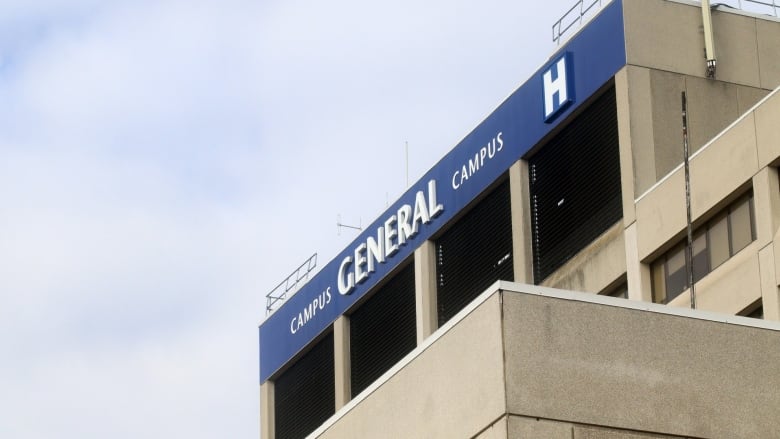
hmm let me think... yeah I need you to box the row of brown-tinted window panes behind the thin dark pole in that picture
[652,193,756,303]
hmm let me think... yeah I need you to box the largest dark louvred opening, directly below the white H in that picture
[528,87,623,284]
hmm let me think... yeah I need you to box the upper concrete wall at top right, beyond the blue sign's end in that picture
[616,0,780,197]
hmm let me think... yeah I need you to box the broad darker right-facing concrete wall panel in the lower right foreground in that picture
[503,293,780,439]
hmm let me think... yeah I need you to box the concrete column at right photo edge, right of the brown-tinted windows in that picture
[753,167,780,320]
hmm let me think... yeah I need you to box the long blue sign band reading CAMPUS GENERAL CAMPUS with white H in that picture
[260,0,626,383]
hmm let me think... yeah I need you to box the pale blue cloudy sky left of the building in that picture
[0,0,588,439]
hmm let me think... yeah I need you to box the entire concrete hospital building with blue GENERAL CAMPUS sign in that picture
[260,0,780,439]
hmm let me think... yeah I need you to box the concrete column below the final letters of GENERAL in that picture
[414,241,439,345]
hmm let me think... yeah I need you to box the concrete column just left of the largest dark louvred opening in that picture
[509,160,534,284]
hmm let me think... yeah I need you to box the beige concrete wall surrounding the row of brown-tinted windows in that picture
[626,88,780,319]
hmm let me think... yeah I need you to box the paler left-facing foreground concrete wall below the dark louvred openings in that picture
[319,294,505,439]
